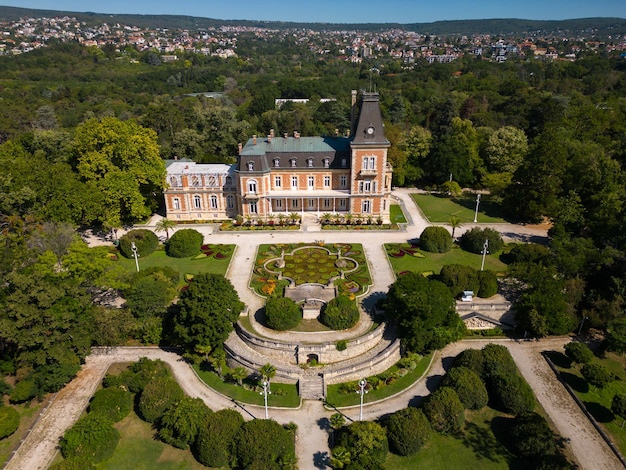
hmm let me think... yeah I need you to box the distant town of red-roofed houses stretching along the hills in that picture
[0,10,626,62]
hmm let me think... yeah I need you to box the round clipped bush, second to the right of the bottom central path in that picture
[386,407,430,456]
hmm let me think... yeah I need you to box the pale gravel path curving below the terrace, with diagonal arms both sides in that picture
[6,338,623,470]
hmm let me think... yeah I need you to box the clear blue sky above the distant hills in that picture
[0,0,626,23]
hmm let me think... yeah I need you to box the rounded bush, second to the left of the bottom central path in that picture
[193,409,244,468]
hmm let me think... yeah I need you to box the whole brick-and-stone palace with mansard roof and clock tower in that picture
[165,91,392,221]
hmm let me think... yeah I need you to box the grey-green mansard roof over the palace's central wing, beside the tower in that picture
[238,136,350,173]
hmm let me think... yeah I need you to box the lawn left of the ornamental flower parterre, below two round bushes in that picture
[113,245,235,284]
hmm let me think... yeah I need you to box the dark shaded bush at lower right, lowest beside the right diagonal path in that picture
[510,413,557,458]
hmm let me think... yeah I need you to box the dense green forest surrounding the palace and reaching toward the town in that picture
[0,33,626,395]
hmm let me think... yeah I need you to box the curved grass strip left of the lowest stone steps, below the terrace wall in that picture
[193,365,300,408]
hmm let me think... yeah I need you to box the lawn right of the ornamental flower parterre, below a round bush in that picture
[385,243,507,274]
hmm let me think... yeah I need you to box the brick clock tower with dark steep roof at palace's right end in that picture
[350,92,392,220]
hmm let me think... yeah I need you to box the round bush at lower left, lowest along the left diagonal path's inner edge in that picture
[59,413,120,462]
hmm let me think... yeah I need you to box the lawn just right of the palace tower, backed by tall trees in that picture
[411,194,507,224]
